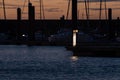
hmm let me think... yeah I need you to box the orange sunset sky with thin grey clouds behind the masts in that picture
[0,0,120,19]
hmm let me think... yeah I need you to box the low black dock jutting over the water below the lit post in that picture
[66,42,120,57]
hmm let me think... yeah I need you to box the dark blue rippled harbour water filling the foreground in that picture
[0,45,120,80]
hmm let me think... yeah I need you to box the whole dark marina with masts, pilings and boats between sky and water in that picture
[0,0,120,56]
